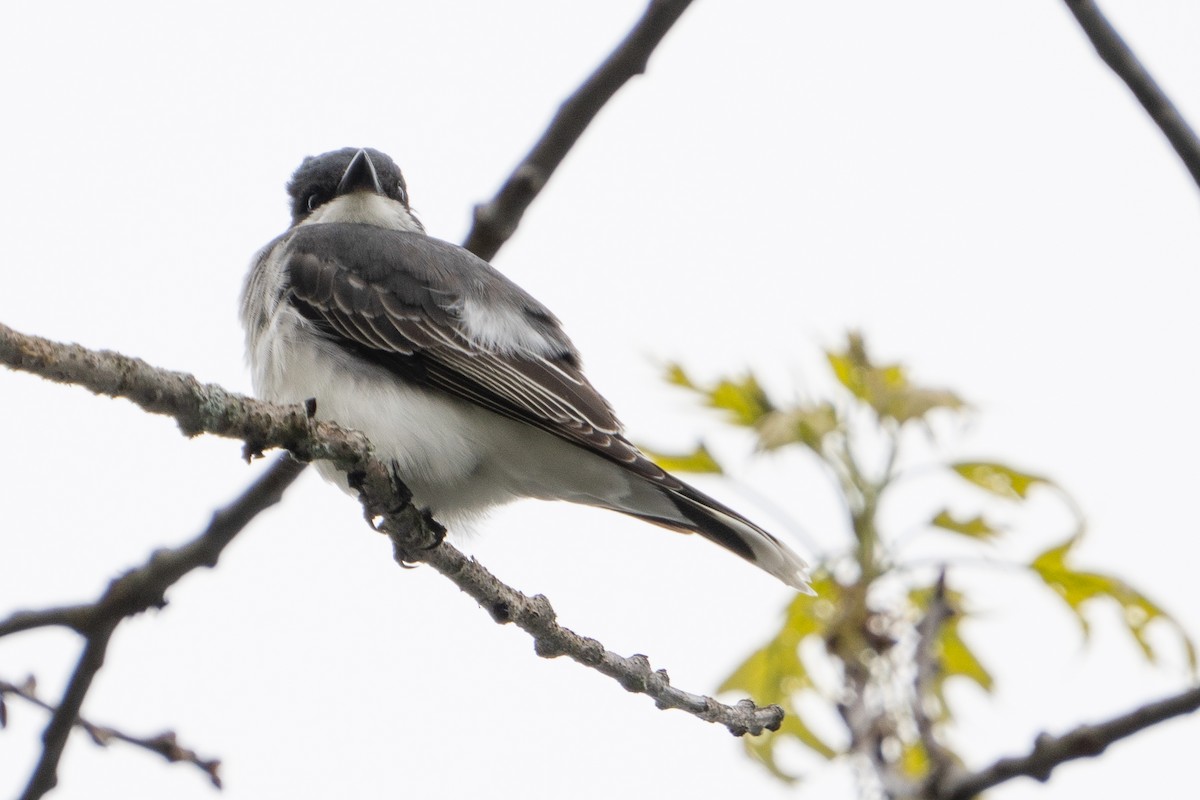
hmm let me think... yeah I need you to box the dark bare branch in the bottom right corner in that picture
[936,687,1200,800]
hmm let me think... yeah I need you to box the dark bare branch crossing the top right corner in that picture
[1064,0,1200,186]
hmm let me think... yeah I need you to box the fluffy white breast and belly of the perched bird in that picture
[250,293,668,524]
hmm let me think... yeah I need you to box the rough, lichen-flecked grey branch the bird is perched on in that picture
[0,324,784,735]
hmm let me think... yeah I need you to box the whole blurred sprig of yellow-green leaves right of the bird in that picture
[656,333,1196,795]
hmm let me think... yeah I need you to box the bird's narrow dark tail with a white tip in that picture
[617,479,815,595]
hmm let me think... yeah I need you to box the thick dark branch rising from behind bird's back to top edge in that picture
[463,0,691,260]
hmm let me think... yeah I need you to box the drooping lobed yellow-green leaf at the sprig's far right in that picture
[1028,535,1196,674]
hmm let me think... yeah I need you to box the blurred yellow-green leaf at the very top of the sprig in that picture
[826,333,966,425]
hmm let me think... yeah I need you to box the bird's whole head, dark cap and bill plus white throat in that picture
[288,148,425,233]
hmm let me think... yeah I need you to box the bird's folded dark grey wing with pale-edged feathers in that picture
[277,223,679,488]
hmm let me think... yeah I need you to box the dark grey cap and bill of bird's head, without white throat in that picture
[288,148,420,225]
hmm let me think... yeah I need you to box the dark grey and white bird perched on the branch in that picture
[241,148,812,594]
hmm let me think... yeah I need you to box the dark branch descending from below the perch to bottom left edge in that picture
[11,455,304,800]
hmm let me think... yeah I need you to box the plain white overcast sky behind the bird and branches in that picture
[0,0,1200,800]
